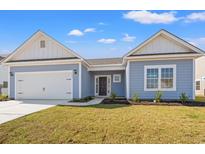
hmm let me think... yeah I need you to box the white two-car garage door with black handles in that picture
[15,71,73,99]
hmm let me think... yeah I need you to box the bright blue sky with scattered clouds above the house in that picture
[0,10,205,58]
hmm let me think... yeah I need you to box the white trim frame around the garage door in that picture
[14,70,74,99]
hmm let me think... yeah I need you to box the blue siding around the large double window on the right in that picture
[129,60,193,99]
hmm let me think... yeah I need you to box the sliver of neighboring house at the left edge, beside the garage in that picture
[0,55,8,95]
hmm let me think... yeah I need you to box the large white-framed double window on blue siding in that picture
[144,65,176,91]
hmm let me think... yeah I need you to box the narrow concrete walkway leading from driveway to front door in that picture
[59,98,104,106]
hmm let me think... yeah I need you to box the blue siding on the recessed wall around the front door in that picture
[91,71,125,96]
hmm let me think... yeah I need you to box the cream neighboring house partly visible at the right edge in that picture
[195,56,205,96]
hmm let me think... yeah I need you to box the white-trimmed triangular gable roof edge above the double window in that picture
[123,29,205,57]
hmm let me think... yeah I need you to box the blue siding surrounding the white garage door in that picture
[10,64,79,98]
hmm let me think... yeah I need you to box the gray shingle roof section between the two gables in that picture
[86,58,122,65]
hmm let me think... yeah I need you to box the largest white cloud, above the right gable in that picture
[123,11,179,24]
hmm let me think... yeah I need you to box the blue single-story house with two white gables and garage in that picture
[3,30,204,99]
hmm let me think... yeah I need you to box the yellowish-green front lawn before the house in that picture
[0,105,205,143]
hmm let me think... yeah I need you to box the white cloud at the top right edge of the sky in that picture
[185,12,205,22]
